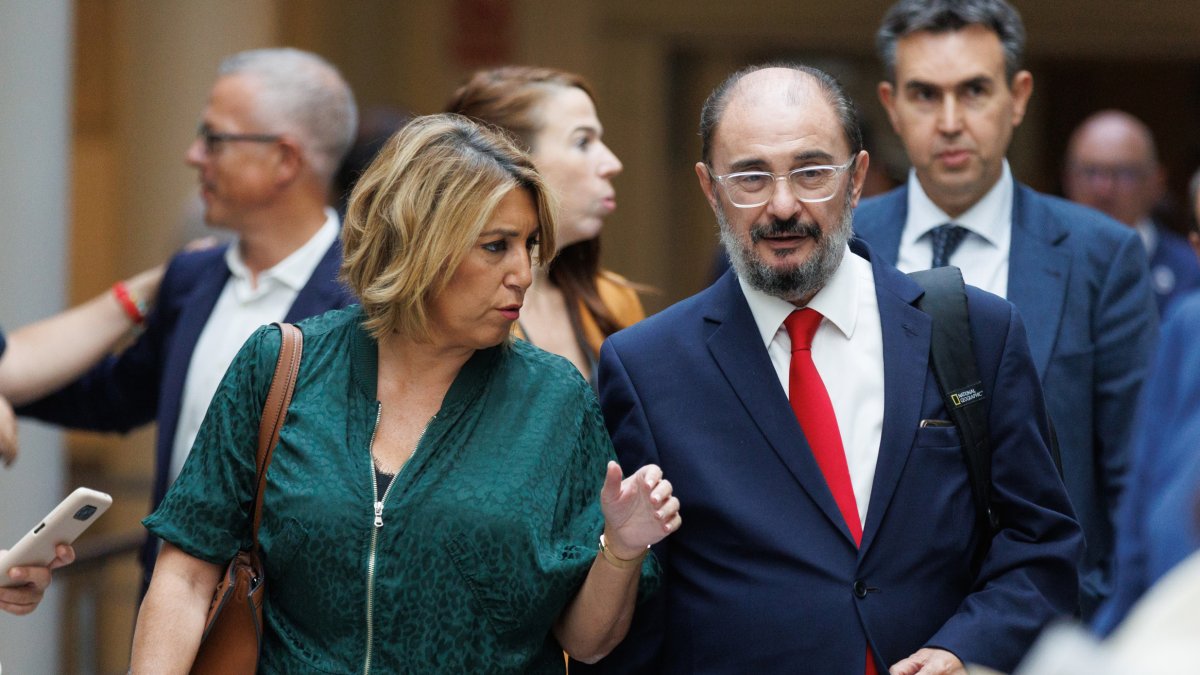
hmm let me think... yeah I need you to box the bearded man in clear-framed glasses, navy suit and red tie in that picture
[572,65,1082,675]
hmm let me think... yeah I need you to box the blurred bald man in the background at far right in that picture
[1062,110,1200,313]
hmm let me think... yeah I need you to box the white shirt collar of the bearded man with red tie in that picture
[738,241,870,347]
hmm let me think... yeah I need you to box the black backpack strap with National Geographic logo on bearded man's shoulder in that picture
[908,267,1000,538]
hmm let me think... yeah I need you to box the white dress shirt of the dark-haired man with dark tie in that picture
[896,160,1014,298]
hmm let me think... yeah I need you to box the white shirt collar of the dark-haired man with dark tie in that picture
[900,160,1013,249]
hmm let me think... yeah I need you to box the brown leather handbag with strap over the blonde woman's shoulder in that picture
[192,323,304,675]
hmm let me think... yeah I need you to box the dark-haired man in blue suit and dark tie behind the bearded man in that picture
[854,0,1158,619]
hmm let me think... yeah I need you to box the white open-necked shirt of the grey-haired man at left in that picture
[170,209,340,482]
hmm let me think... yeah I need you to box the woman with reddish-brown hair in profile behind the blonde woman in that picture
[446,66,646,382]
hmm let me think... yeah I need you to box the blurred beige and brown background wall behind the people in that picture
[51,0,1200,671]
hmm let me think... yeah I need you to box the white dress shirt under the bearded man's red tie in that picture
[738,242,883,525]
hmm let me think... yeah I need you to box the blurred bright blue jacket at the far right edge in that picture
[1096,293,1200,634]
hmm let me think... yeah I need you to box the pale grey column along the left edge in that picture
[0,0,71,673]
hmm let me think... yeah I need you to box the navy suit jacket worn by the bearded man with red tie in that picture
[585,240,1082,675]
